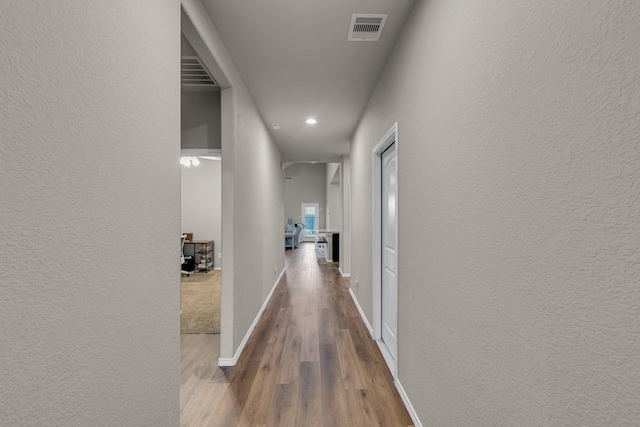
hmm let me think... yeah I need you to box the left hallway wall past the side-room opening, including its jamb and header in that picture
[182,0,285,360]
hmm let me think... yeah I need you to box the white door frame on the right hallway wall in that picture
[371,122,400,381]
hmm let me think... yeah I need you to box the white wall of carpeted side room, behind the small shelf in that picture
[180,159,222,268]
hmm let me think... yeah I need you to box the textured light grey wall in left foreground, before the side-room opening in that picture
[0,0,180,426]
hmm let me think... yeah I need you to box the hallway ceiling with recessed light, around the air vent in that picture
[196,0,414,162]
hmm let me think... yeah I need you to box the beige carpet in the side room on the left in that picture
[180,270,220,334]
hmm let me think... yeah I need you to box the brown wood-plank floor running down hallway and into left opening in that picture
[180,243,413,427]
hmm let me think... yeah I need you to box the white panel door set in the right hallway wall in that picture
[381,144,398,361]
